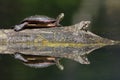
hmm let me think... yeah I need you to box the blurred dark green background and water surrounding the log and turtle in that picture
[0,0,120,80]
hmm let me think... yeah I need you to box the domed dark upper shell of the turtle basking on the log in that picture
[21,15,56,24]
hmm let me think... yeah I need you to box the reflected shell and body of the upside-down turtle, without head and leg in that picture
[24,55,55,68]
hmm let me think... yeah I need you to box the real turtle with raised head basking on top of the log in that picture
[14,13,64,31]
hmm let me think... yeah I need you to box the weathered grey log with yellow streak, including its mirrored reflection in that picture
[0,21,120,64]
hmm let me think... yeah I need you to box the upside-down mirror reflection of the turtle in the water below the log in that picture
[14,53,64,70]
